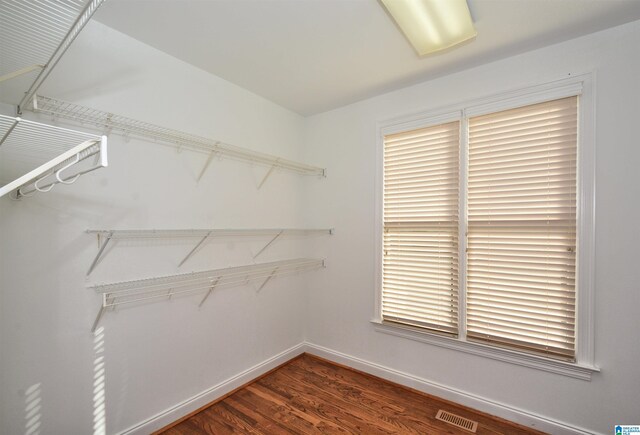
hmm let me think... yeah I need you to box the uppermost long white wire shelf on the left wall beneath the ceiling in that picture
[33,95,325,177]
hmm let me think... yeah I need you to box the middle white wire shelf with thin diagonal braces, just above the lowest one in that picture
[87,228,333,276]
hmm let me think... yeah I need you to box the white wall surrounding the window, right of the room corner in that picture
[303,18,640,433]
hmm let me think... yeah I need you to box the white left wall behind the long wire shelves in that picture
[0,22,322,435]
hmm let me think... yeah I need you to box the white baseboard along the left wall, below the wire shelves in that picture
[120,343,305,435]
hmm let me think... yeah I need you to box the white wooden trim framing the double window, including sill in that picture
[372,73,600,380]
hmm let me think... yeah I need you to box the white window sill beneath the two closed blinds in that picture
[371,320,600,381]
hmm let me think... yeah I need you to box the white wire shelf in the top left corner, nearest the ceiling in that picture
[0,0,103,114]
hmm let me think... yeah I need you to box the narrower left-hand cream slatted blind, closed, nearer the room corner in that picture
[382,121,460,335]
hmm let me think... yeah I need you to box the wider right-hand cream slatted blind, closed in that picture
[466,97,578,360]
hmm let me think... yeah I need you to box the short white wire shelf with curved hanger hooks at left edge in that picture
[0,115,108,199]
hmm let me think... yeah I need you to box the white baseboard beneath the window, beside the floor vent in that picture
[304,342,596,435]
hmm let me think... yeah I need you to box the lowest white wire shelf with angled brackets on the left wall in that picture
[89,258,324,331]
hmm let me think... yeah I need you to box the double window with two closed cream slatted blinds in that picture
[378,78,593,374]
